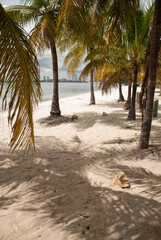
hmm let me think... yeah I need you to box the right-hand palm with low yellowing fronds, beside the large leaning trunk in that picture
[82,6,153,120]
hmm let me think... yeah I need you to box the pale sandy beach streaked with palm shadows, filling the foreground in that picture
[0,87,161,240]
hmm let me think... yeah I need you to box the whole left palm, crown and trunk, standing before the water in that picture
[8,0,62,116]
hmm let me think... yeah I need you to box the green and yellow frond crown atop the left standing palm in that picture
[6,0,61,52]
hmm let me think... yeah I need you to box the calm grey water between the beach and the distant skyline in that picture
[0,82,98,110]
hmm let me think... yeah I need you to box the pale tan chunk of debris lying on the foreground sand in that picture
[113,171,130,188]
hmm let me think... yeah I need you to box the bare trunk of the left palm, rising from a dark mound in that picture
[50,42,61,116]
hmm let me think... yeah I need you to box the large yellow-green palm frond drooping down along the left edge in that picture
[0,4,41,151]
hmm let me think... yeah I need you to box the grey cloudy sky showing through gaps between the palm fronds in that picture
[0,0,153,79]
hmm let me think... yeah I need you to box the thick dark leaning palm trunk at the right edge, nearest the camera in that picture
[139,0,161,149]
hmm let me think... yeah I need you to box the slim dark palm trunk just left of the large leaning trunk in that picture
[127,64,138,120]
